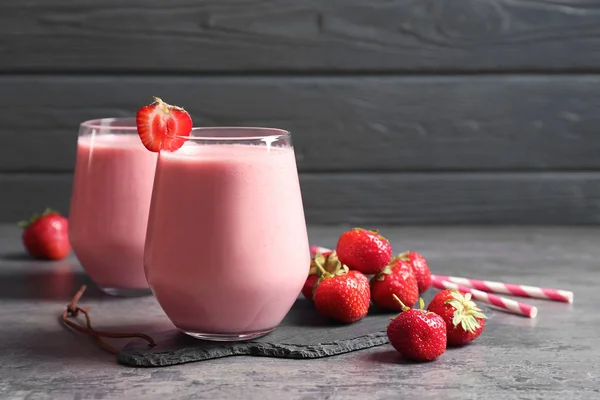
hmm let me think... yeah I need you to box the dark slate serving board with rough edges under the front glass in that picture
[117,299,397,367]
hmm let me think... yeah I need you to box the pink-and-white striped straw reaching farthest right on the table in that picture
[432,275,573,303]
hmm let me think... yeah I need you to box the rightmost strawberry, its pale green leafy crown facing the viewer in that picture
[427,290,486,346]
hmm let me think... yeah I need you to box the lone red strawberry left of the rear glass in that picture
[19,209,71,260]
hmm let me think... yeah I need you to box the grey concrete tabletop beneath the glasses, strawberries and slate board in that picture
[0,226,600,399]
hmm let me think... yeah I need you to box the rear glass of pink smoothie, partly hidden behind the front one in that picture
[69,118,158,296]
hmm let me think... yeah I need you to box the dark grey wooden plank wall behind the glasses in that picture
[0,0,600,225]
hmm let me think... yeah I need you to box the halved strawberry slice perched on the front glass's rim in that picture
[136,97,192,152]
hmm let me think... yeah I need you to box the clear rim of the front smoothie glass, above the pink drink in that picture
[173,126,291,142]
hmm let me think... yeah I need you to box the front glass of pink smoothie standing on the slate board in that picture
[145,127,310,341]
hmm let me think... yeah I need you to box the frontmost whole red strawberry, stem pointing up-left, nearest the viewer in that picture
[387,299,446,361]
